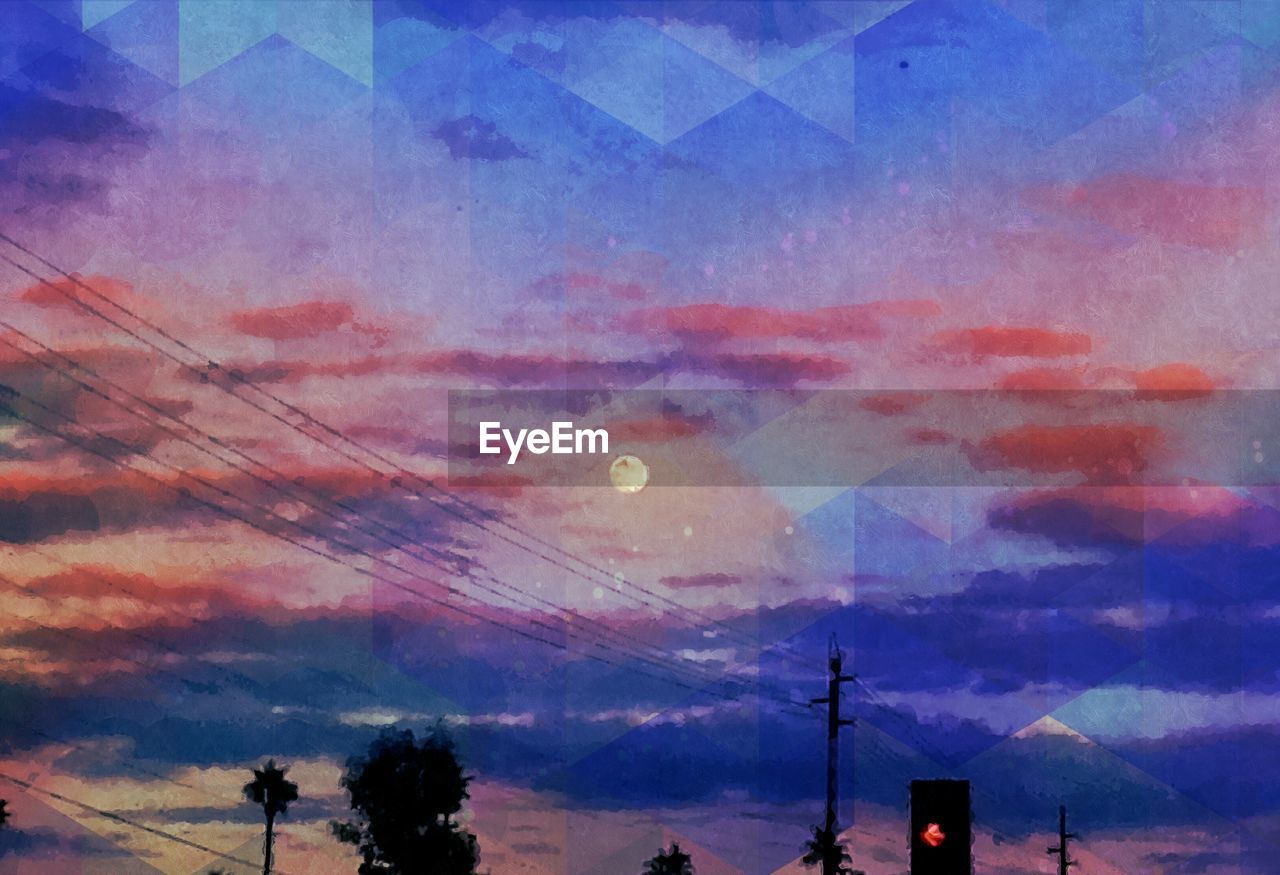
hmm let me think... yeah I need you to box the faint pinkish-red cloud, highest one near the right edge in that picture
[1030,174,1265,249]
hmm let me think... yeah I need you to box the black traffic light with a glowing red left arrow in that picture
[911,780,973,875]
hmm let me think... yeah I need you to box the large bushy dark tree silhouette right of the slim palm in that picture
[330,727,480,875]
